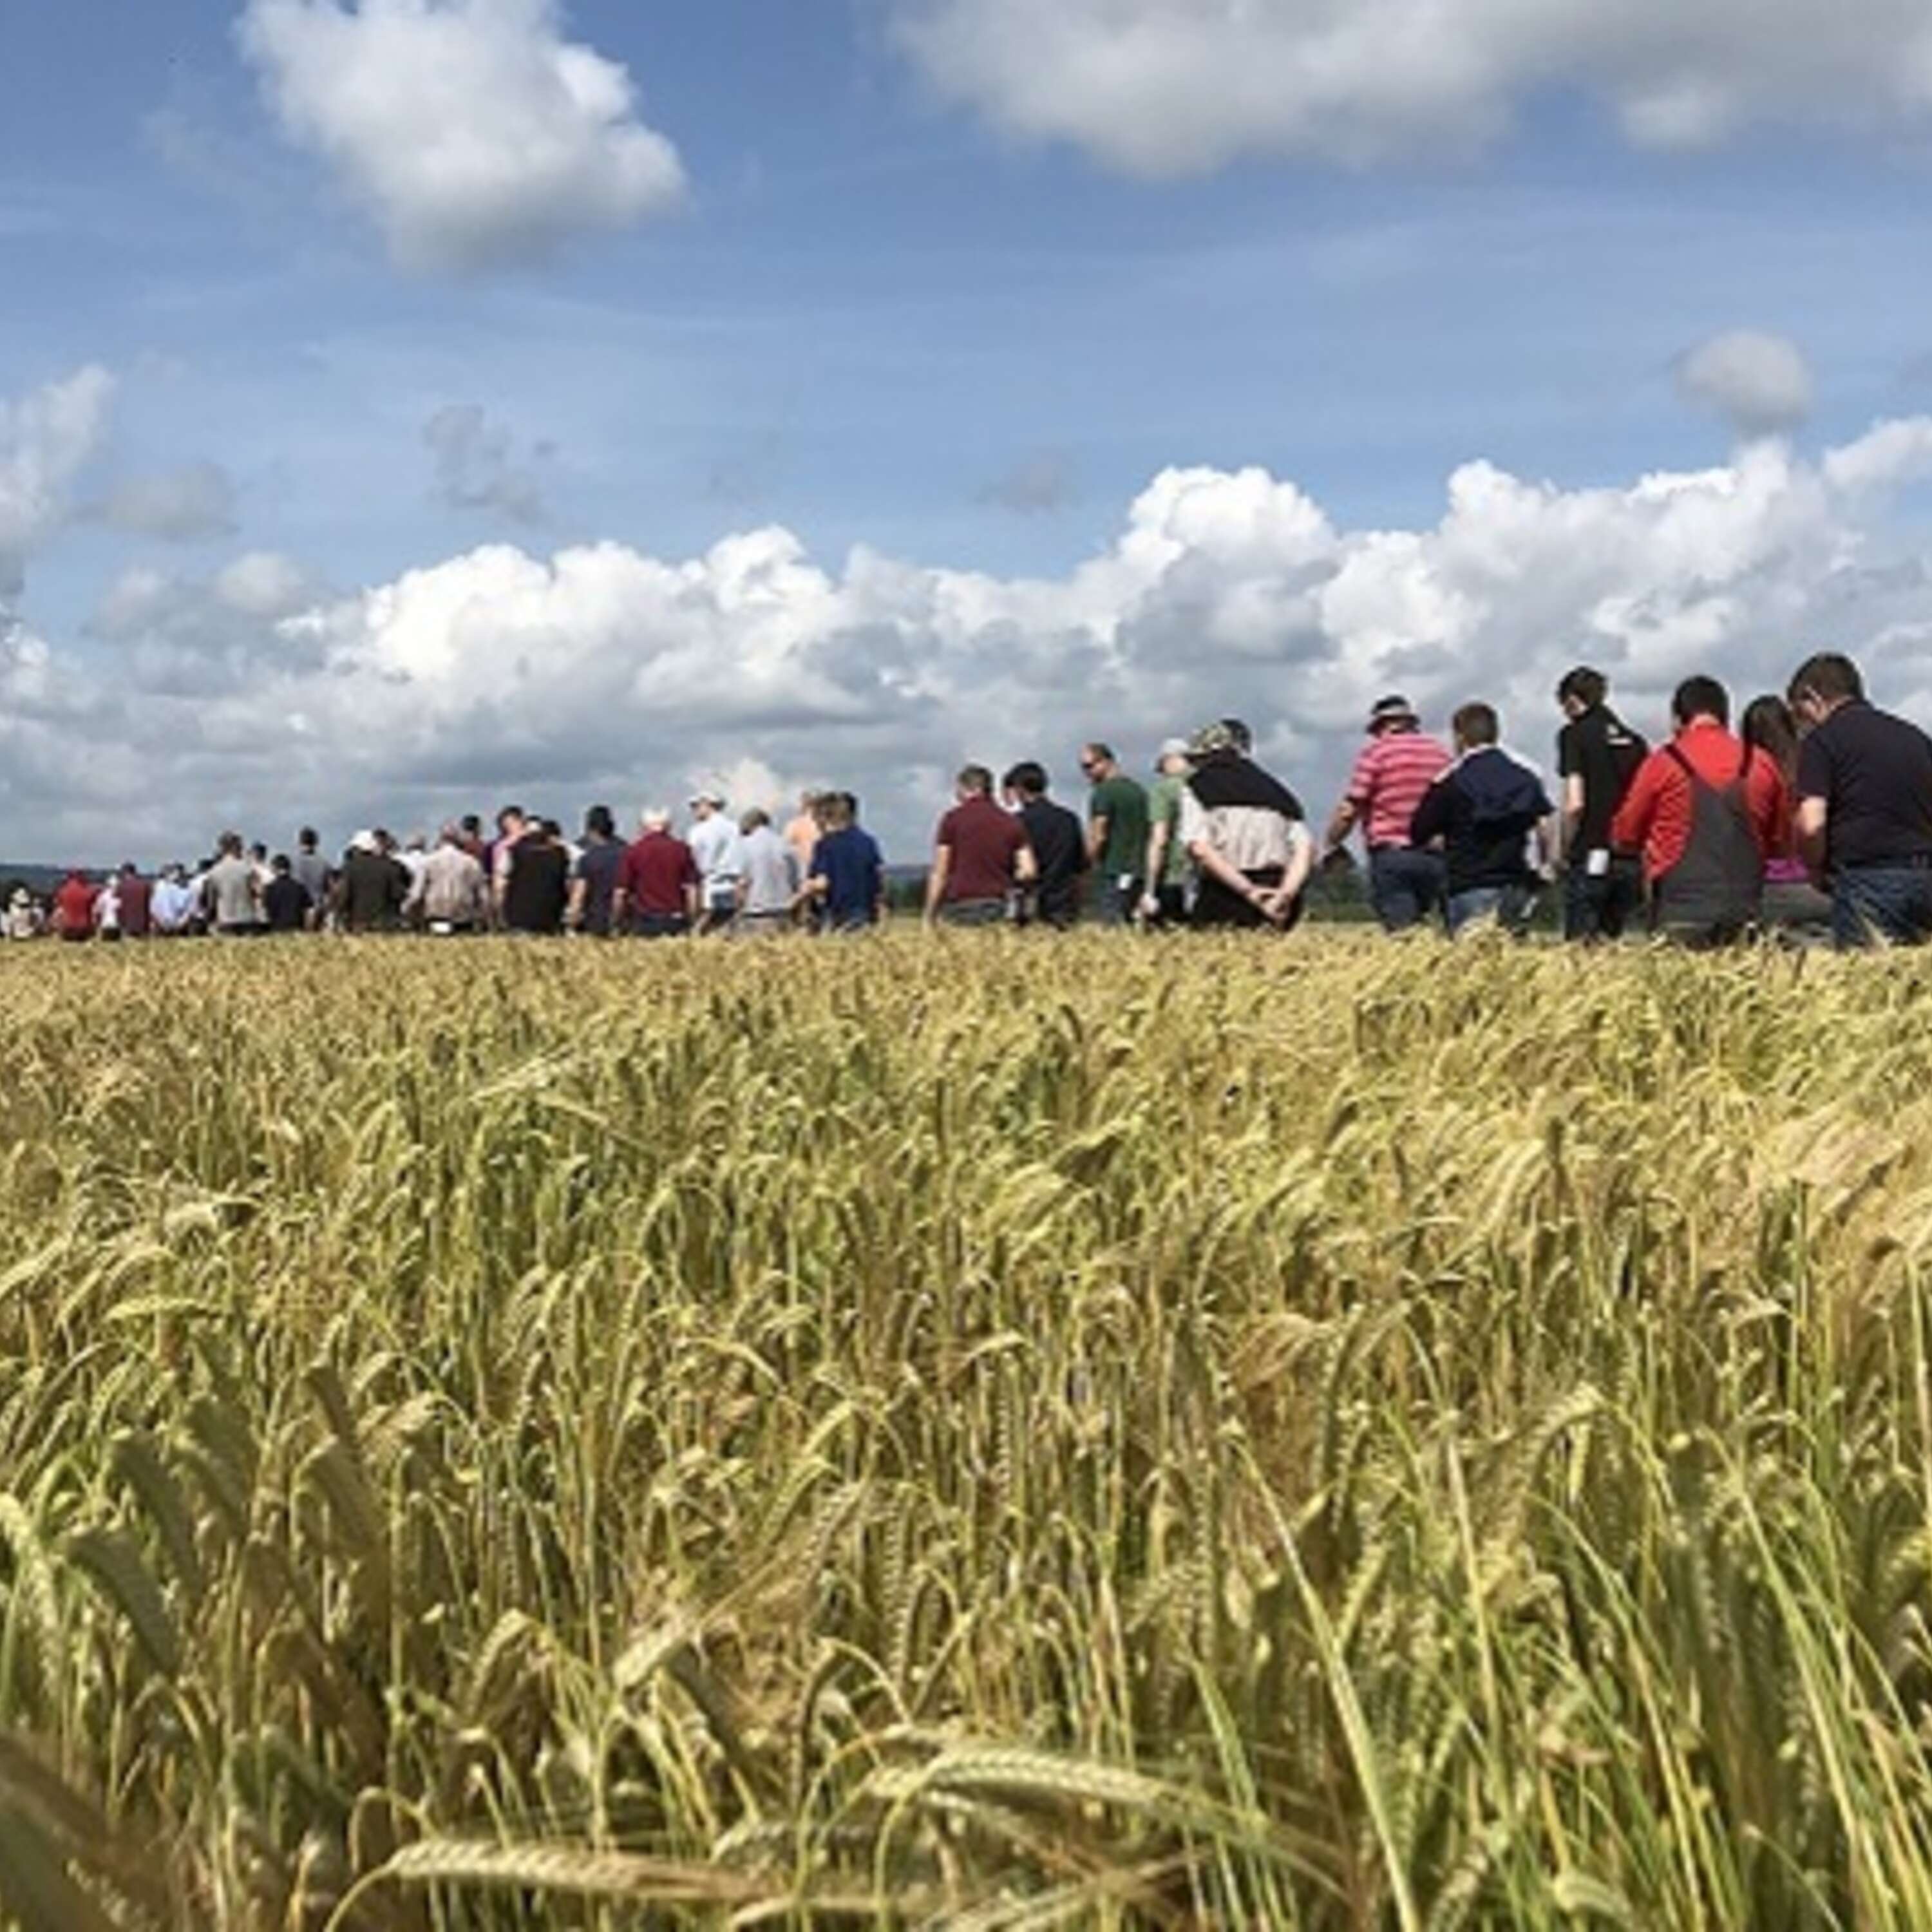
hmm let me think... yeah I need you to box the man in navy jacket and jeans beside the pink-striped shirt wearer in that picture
[1408,703,1555,937]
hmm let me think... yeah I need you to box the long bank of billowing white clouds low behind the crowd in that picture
[11,377,1932,858]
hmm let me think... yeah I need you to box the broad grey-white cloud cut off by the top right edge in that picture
[887,0,1932,176]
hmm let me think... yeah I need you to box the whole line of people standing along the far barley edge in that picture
[11,653,1932,947]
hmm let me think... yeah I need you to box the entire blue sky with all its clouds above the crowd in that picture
[0,0,1932,864]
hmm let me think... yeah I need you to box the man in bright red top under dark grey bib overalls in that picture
[1609,678,1789,945]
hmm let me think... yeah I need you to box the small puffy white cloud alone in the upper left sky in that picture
[238,0,684,272]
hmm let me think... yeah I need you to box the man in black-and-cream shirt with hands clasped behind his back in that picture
[1180,719,1316,931]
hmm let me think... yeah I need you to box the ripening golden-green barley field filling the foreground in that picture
[0,933,1932,1932]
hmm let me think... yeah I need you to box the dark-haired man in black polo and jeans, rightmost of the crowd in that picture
[1789,651,1932,947]
